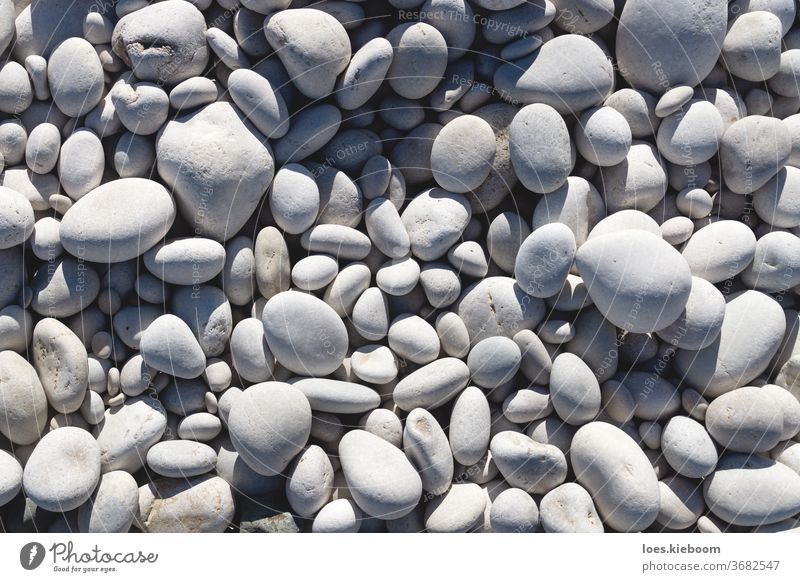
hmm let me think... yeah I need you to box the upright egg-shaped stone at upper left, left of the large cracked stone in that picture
[47,38,105,117]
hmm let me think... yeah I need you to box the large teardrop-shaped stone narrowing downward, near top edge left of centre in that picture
[264,8,350,99]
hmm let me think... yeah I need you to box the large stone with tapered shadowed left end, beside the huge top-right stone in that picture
[494,34,612,114]
